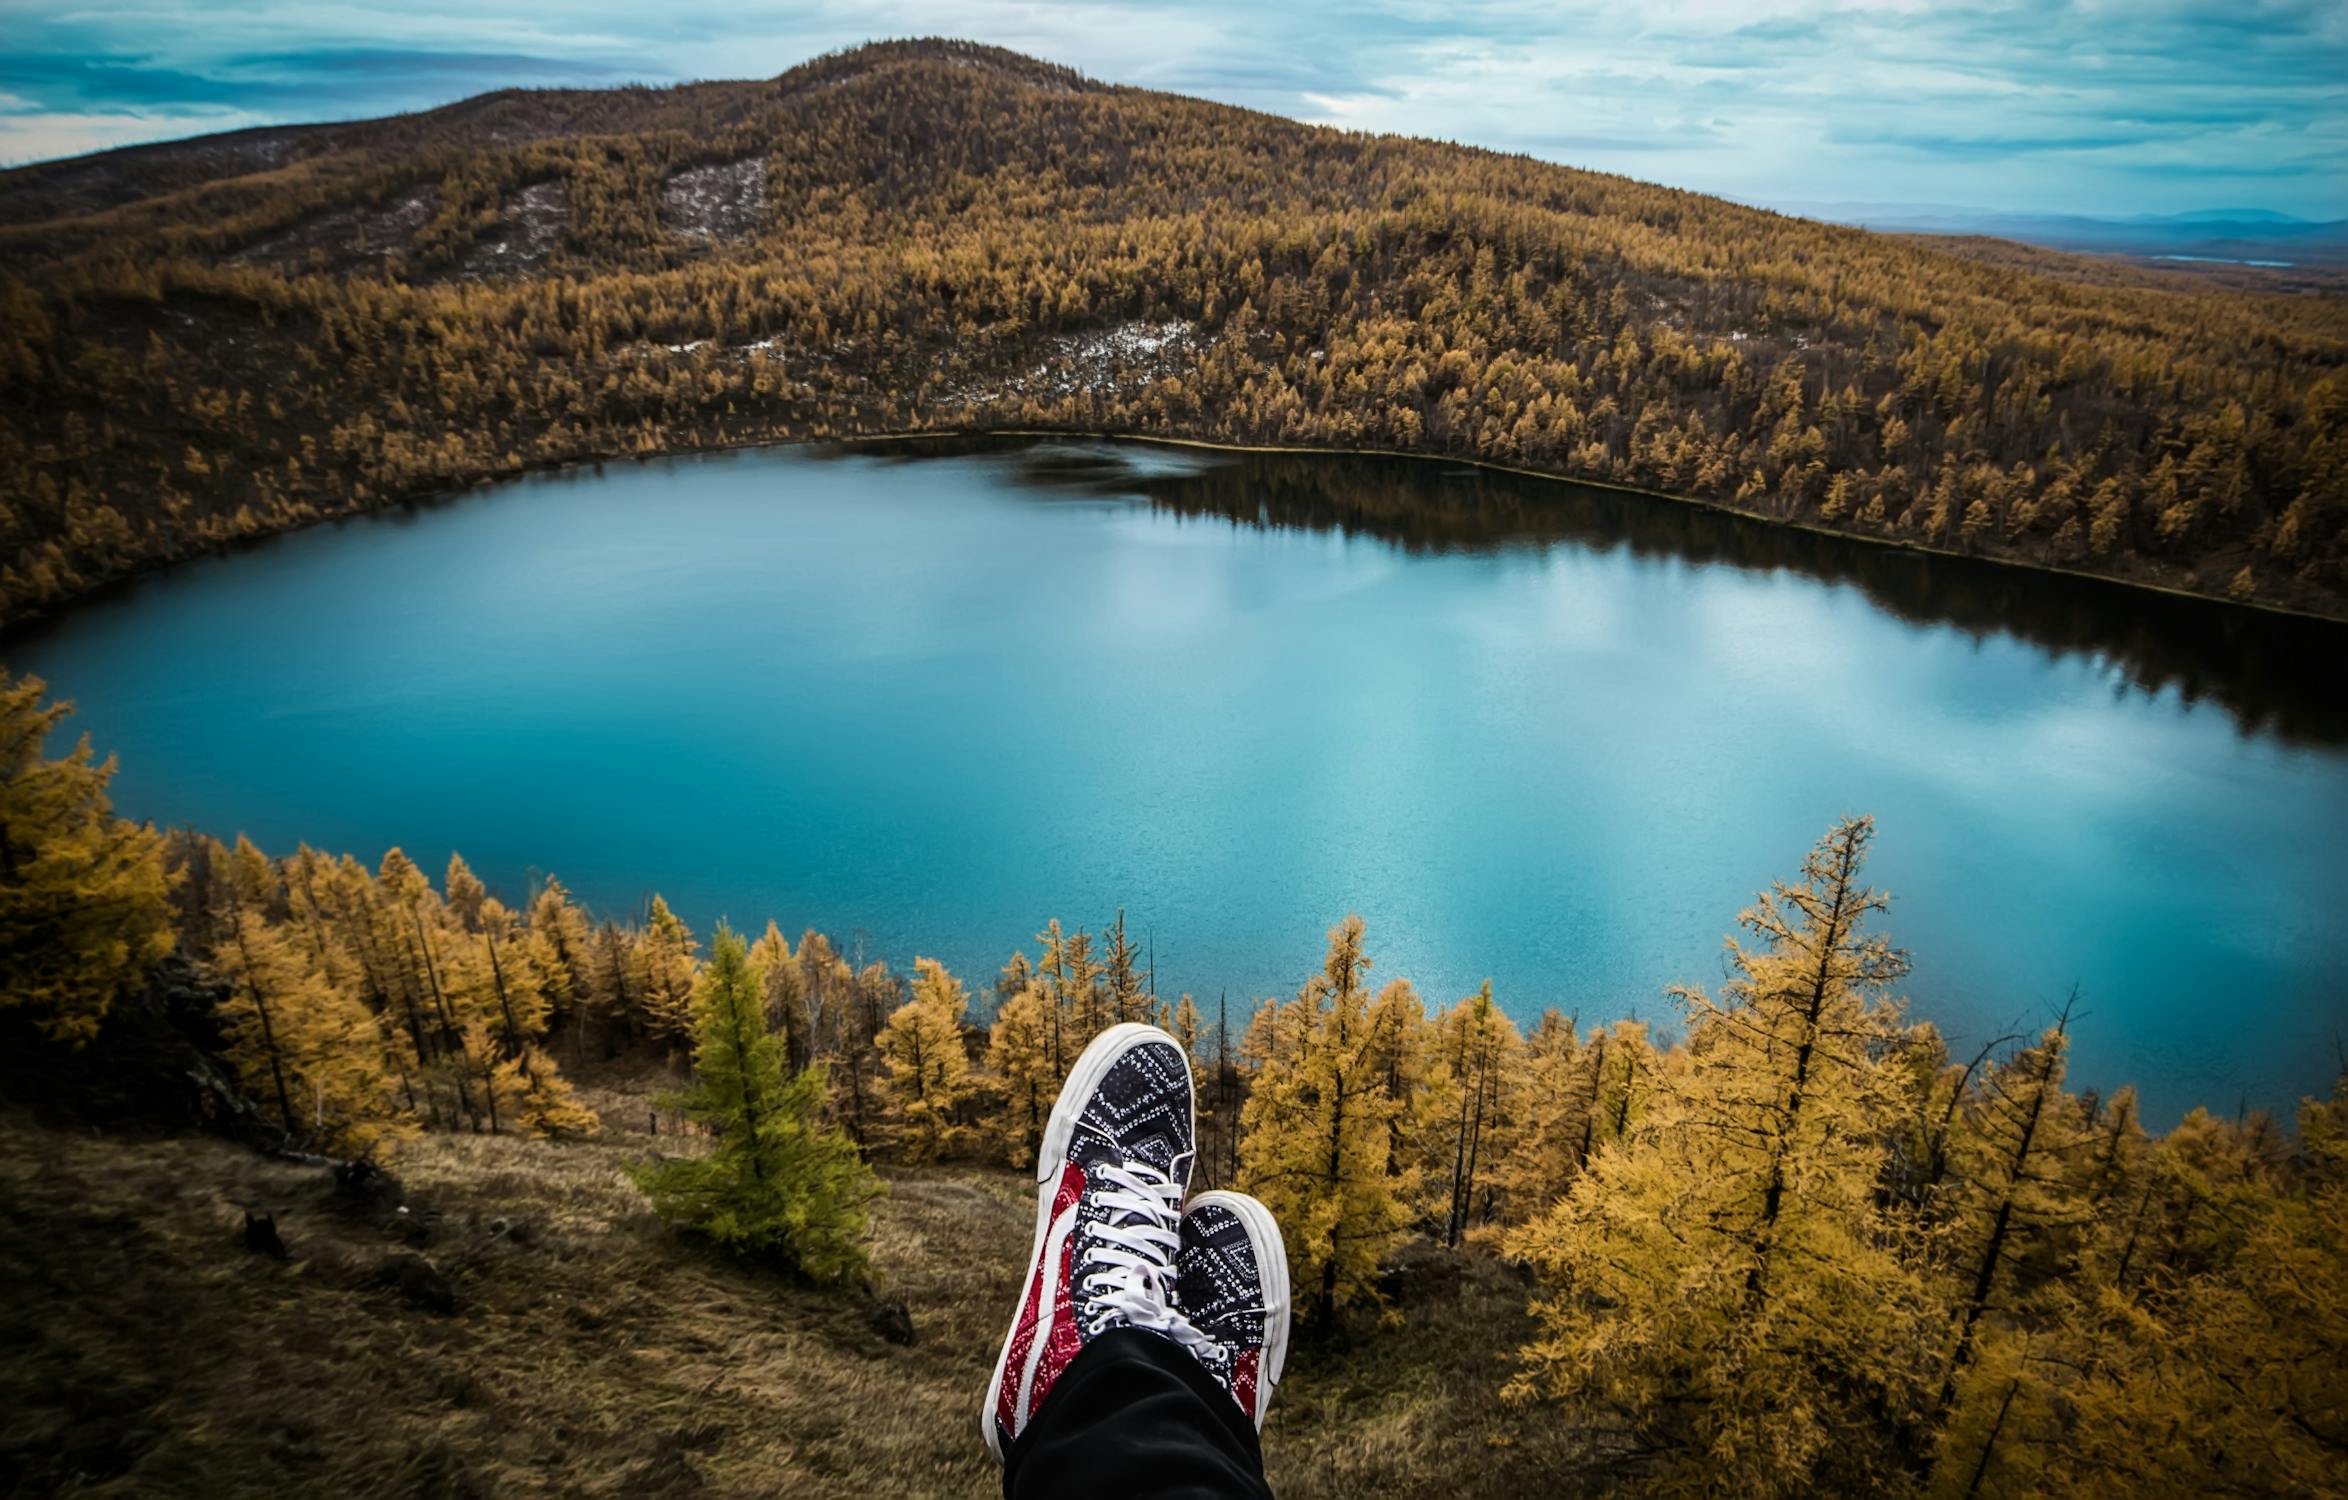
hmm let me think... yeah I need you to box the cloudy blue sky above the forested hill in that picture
[0,0,2348,218]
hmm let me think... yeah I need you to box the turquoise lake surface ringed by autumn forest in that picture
[7,444,2348,1122]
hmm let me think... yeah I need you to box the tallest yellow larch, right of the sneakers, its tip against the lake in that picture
[1510,819,1937,1495]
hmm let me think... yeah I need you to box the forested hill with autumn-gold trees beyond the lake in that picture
[0,42,2348,617]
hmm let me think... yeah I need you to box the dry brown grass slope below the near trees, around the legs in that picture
[0,1085,1606,1498]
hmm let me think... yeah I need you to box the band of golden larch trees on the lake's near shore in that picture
[0,678,2348,1495]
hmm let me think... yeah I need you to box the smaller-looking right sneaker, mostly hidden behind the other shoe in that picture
[1174,1192,1289,1432]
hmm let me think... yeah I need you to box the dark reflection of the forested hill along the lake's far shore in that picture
[848,439,2348,746]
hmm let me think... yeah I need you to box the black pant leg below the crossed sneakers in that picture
[1003,1329,1273,1500]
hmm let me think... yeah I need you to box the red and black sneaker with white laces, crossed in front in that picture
[979,1023,1207,1462]
